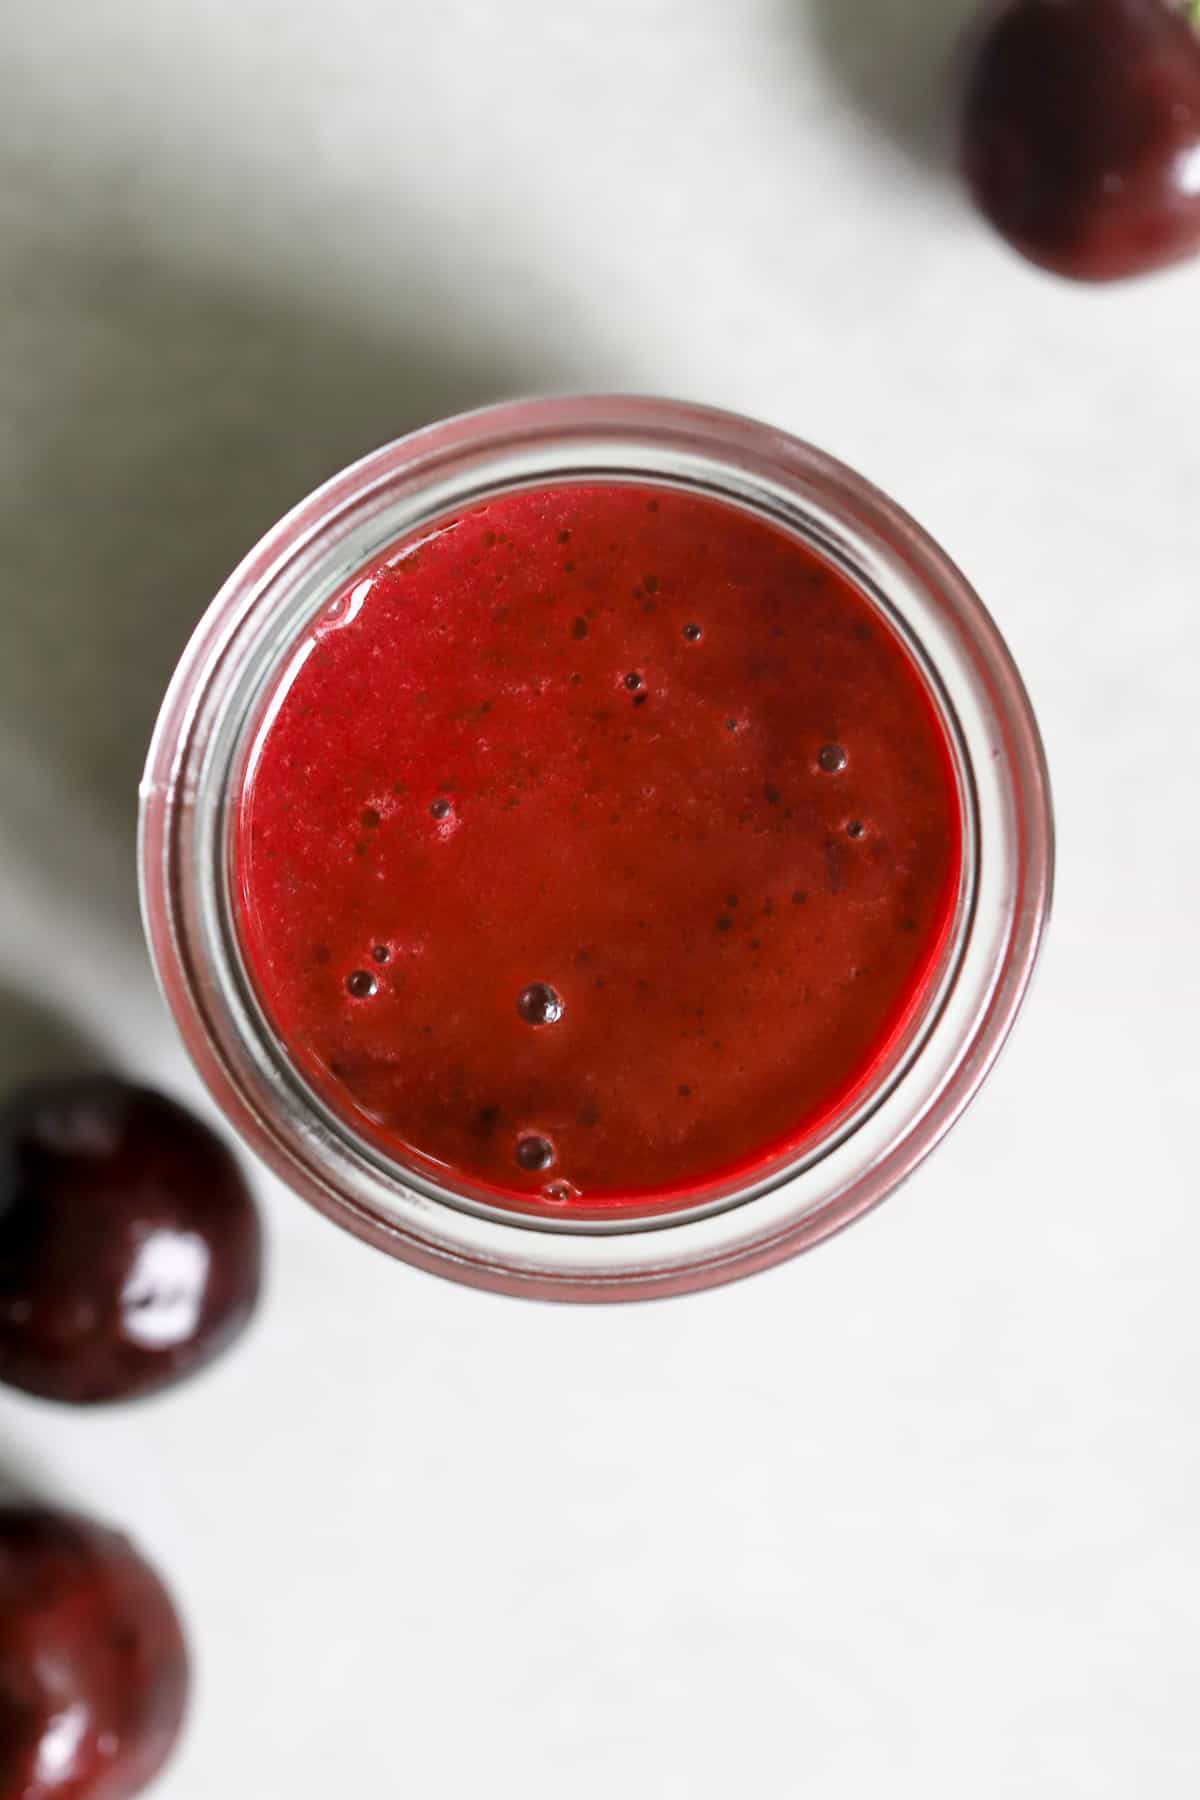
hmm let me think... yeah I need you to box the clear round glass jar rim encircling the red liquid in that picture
[140,398,1052,1298]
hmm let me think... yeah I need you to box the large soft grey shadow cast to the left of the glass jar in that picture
[0,178,568,932]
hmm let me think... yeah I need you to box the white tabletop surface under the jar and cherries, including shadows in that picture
[0,0,1200,1800]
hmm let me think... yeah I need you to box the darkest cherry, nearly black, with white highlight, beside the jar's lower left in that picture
[0,1076,261,1396]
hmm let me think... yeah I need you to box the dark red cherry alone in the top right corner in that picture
[961,0,1200,281]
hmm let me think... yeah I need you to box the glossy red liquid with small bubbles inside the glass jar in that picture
[236,484,963,1211]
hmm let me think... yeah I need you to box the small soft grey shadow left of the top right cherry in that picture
[798,0,979,169]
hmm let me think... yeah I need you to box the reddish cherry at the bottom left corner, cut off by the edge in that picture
[0,1507,187,1800]
